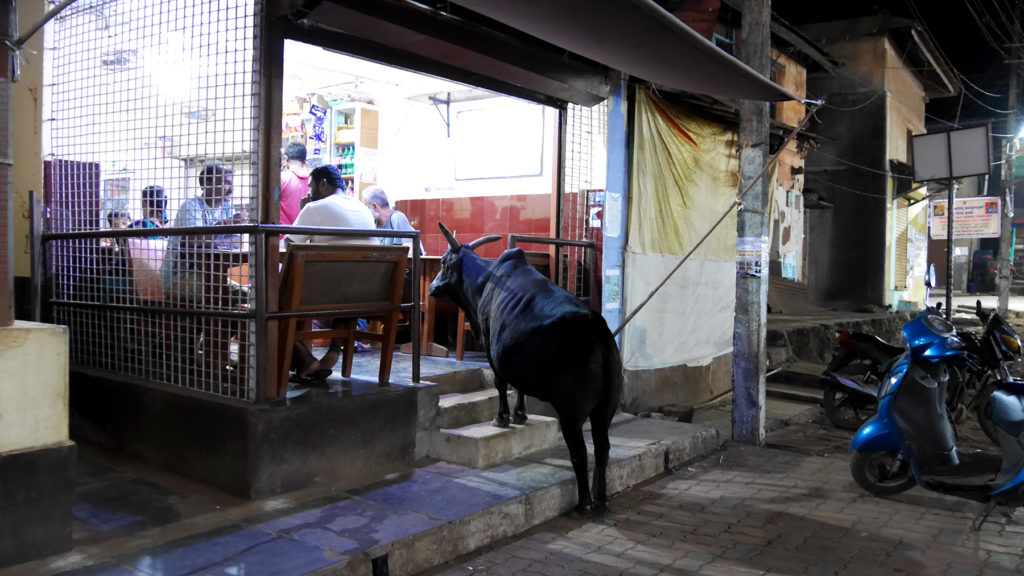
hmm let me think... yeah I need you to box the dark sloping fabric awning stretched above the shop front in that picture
[452,0,801,101]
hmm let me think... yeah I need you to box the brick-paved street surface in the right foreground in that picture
[423,422,1024,576]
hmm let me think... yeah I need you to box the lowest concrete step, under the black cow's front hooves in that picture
[428,414,561,468]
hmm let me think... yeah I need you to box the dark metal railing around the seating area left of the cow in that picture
[33,217,422,402]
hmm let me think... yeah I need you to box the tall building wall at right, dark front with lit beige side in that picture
[807,36,926,307]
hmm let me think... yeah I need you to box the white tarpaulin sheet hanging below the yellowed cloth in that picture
[623,251,736,370]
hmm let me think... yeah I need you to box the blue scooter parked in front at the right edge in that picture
[850,307,1024,520]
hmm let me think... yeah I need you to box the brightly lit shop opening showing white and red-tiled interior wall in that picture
[282,41,559,257]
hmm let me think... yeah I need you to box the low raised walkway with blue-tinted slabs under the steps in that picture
[6,418,725,576]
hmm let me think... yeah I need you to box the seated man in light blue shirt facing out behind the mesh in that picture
[161,162,246,303]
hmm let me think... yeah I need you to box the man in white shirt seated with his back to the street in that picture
[285,165,377,380]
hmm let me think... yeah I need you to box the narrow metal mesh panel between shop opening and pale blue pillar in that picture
[559,101,608,298]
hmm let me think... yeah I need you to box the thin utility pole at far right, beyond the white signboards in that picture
[995,24,1020,318]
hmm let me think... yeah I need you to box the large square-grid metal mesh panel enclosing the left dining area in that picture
[44,0,260,400]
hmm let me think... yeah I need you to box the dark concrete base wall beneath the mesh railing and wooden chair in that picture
[71,373,419,498]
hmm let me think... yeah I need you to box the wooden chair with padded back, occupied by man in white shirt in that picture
[274,244,409,397]
